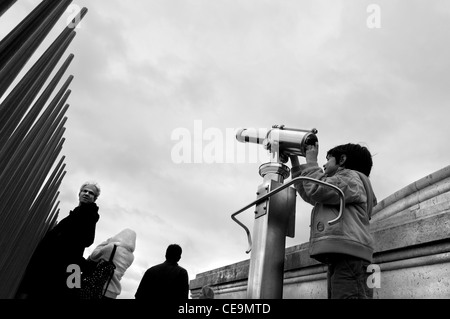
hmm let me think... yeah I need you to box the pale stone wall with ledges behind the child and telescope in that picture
[190,166,450,299]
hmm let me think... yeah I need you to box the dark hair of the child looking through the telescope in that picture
[327,143,373,177]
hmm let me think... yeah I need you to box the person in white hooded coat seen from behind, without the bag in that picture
[89,228,136,299]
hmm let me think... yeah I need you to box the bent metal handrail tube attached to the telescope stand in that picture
[231,176,345,254]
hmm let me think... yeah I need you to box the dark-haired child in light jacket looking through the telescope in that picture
[290,143,377,299]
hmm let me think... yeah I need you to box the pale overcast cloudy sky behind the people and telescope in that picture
[0,0,450,298]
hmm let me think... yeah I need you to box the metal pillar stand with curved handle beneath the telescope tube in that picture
[231,156,345,299]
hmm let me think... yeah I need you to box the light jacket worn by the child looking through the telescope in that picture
[291,163,377,263]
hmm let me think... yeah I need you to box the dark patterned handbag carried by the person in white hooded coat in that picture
[80,245,117,299]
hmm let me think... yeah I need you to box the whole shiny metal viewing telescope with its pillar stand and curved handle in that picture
[231,125,344,299]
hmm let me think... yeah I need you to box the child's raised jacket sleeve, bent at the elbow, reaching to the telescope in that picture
[293,164,366,205]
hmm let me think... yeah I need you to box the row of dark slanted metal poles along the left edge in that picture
[0,0,87,299]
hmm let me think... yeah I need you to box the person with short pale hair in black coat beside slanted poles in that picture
[17,182,100,299]
